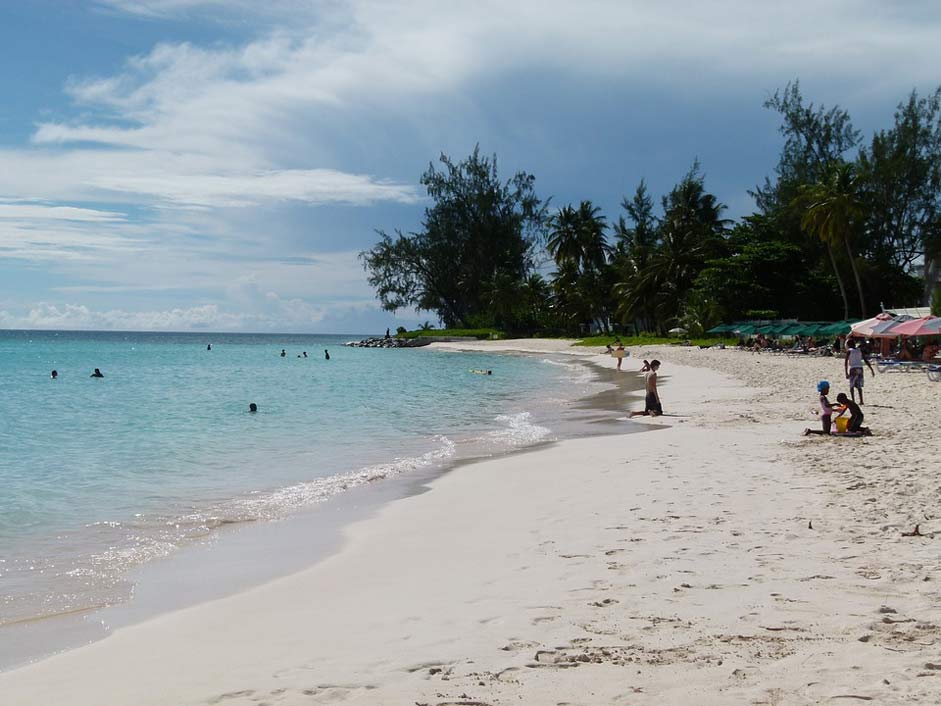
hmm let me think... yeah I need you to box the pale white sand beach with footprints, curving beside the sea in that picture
[0,341,941,706]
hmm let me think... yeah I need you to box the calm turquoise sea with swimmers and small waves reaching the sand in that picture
[0,331,587,626]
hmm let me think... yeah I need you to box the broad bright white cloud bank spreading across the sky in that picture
[7,0,941,328]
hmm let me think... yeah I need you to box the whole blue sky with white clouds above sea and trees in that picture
[0,0,941,333]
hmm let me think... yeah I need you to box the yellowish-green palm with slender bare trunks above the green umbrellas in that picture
[797,163,866,319]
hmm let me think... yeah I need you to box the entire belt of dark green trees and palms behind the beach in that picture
[361,81,941,343]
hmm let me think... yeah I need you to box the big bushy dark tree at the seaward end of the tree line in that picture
[360,148,545,326]
